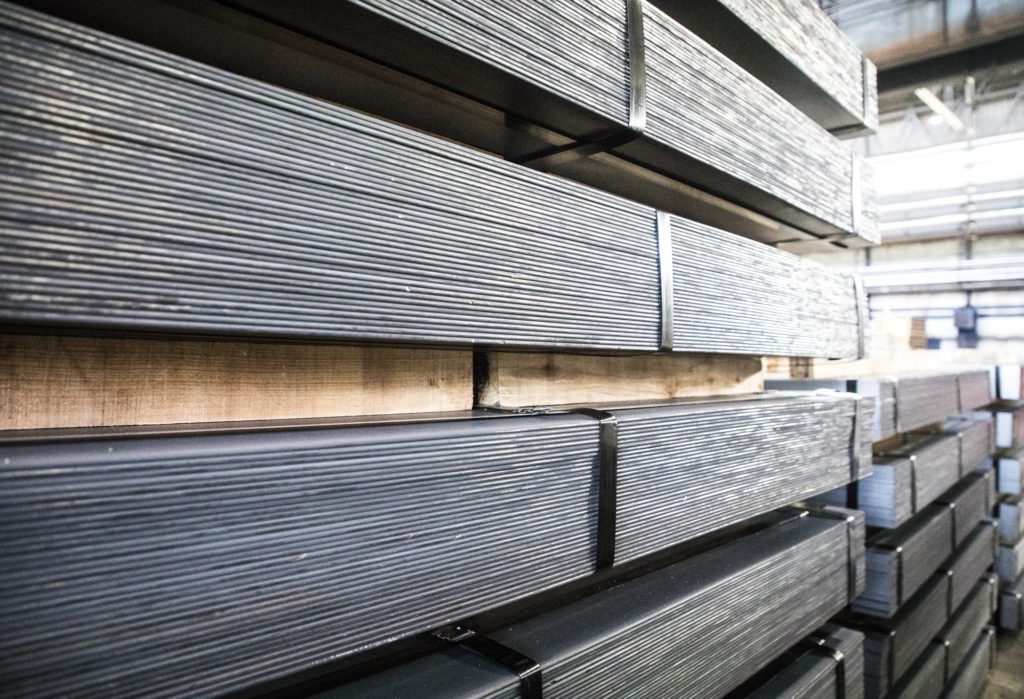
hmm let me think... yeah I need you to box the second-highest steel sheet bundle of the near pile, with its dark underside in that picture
[14,0,878,247]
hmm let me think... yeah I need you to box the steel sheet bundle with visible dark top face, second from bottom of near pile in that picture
[326,507,863,697]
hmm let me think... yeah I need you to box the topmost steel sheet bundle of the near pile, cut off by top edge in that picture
[653,0,879,134]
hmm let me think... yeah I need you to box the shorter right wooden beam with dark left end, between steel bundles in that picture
[476,352,764,407]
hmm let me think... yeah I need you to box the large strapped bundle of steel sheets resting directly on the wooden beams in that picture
[0,4,865,357]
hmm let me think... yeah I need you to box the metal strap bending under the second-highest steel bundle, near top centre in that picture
[509,0,647,170]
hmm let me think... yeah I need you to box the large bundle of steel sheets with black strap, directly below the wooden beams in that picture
[0,394,868,695]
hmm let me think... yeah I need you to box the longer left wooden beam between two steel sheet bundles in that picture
[0,335,473,430]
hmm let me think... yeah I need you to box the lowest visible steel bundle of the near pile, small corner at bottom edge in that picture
[729,624,864,699]
